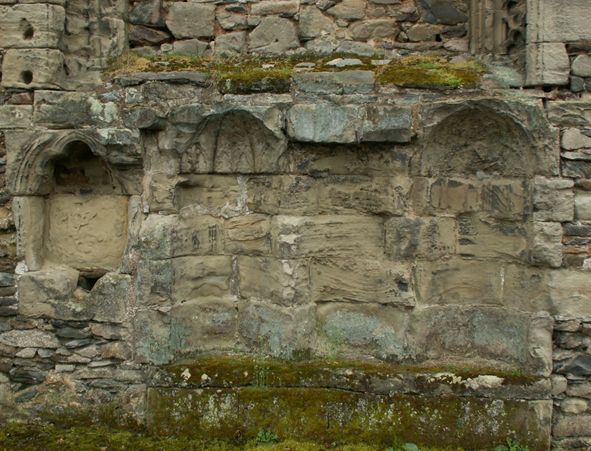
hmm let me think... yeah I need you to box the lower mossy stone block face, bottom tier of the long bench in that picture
[147,387,552,450]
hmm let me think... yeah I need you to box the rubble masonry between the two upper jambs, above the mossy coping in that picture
[129,0,468,55]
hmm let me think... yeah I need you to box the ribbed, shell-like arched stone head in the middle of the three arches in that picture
[179,109,287,174]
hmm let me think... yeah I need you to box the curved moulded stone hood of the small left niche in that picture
[8,130,126,196]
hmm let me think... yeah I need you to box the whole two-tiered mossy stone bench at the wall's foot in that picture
[147,356,552,450]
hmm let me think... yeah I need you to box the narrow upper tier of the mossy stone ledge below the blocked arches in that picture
[150,356,551,400]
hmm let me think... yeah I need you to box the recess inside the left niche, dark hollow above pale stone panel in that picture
[44,141,128,273]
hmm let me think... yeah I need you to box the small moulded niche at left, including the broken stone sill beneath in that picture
[8,131,139,320]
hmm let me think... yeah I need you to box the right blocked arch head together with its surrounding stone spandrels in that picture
[414,98,558,178]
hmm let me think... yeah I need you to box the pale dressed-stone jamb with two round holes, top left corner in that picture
[0,0,127,90]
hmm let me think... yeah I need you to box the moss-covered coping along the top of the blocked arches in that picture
[106,52,486,92]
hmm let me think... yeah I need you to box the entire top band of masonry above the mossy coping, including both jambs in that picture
[0,0,591,92]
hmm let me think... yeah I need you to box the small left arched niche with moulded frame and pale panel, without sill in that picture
[11,132,129,278]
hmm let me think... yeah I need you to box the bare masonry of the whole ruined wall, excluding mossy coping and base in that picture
[0,0,591,449]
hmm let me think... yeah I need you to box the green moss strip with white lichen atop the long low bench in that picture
[162,355,540,391]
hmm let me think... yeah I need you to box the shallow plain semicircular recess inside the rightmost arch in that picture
[419,103,536,177]
